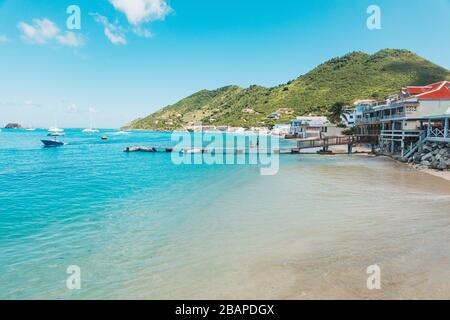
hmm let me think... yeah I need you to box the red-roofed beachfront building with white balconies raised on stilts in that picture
[355,81,450,158]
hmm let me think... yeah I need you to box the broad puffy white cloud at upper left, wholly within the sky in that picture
[18,18,84,47]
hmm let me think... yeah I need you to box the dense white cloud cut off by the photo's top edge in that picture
[109,0,172,26]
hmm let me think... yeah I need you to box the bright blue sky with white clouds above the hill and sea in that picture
[0,0,450,128]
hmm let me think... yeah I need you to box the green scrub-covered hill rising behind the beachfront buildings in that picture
[125,49,450,130]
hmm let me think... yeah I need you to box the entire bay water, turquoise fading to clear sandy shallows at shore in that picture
[0,130,450,299]
